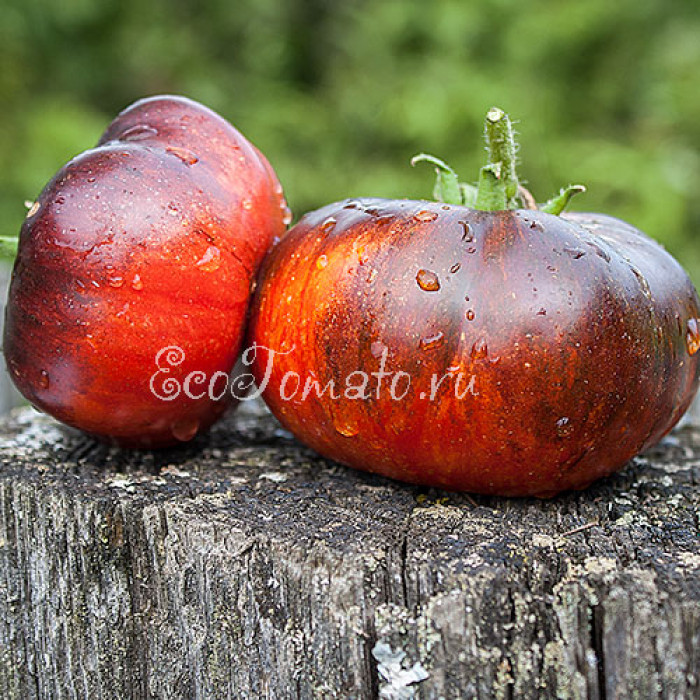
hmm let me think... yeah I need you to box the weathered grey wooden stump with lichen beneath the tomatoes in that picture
[0,400,700,700]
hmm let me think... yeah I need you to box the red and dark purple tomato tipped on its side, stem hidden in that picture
[4,96,288,447]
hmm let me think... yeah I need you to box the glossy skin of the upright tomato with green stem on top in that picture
[248,199,700,497]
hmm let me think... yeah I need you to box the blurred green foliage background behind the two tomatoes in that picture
[0,0,700,284]
